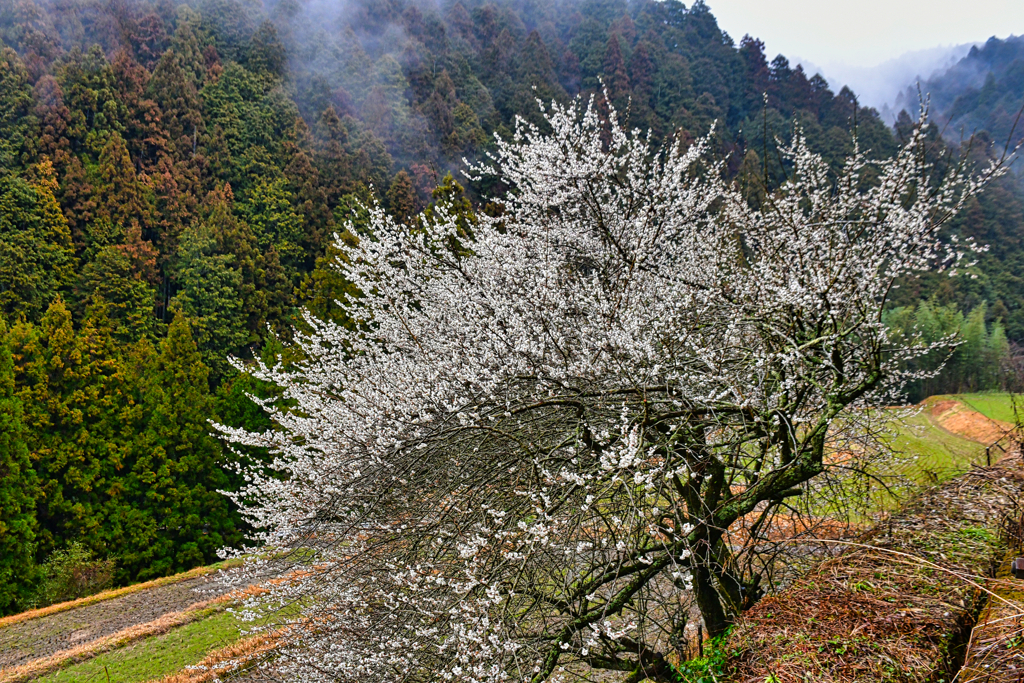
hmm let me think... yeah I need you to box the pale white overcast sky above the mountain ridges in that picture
[704,0,1024,67]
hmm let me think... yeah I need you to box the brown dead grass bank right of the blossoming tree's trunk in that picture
[726,458,1024,683]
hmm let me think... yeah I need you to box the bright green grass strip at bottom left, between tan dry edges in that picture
[36,611,242,683]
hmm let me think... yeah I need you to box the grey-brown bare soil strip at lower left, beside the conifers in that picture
[0,571,238,669]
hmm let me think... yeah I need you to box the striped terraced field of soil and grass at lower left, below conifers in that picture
[0,566,284,683]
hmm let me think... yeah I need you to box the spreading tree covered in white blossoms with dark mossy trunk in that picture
[223,102,995,682]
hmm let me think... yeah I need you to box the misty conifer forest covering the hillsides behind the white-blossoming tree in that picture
[0,0,1024,612]
